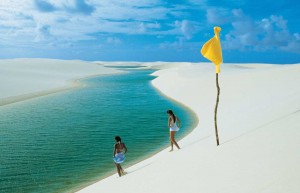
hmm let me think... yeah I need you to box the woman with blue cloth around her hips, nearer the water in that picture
[113,136,127,177]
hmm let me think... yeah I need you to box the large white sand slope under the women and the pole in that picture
[80,63,300,193]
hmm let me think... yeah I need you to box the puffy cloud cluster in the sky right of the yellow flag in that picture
[223,10,300,53]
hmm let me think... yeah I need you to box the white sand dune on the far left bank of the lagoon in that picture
[0,59,120,105]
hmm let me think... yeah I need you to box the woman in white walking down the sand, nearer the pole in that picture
[167,110,181,151]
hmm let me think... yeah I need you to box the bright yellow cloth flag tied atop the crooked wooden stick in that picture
[201,27,223,73]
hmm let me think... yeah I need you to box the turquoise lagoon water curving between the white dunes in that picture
[0,69,197,193]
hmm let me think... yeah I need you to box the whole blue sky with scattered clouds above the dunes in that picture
[0,0,300,63]
